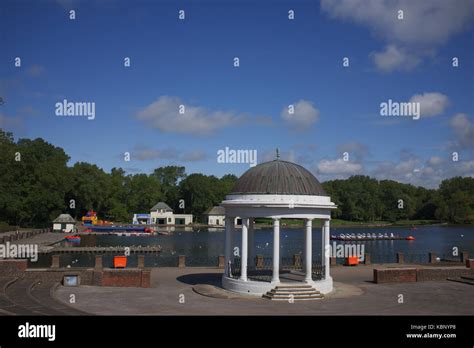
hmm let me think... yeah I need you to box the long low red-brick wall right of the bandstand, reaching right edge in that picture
[374,267,474,284]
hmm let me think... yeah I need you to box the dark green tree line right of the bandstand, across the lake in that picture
[323,175,474,223]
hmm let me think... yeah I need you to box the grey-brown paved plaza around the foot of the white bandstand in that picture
[55,265,474,315]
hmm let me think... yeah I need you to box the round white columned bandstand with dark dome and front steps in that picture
[221,155,336,295]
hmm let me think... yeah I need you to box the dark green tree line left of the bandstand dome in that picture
[0,129,237,227]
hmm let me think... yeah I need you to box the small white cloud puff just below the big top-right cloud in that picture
[371,45,421,72]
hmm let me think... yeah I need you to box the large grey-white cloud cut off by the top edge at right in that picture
[321,0,474,47]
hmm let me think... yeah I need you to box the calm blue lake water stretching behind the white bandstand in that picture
[31,226,474,267]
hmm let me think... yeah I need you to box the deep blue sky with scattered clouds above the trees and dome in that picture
[0,0,474,187]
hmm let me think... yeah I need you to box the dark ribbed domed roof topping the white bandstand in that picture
[231,159,326,196]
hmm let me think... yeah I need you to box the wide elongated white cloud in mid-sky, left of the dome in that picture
[136,96,243,135]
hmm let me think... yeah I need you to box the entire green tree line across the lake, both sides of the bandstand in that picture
[0,129,474,227]
